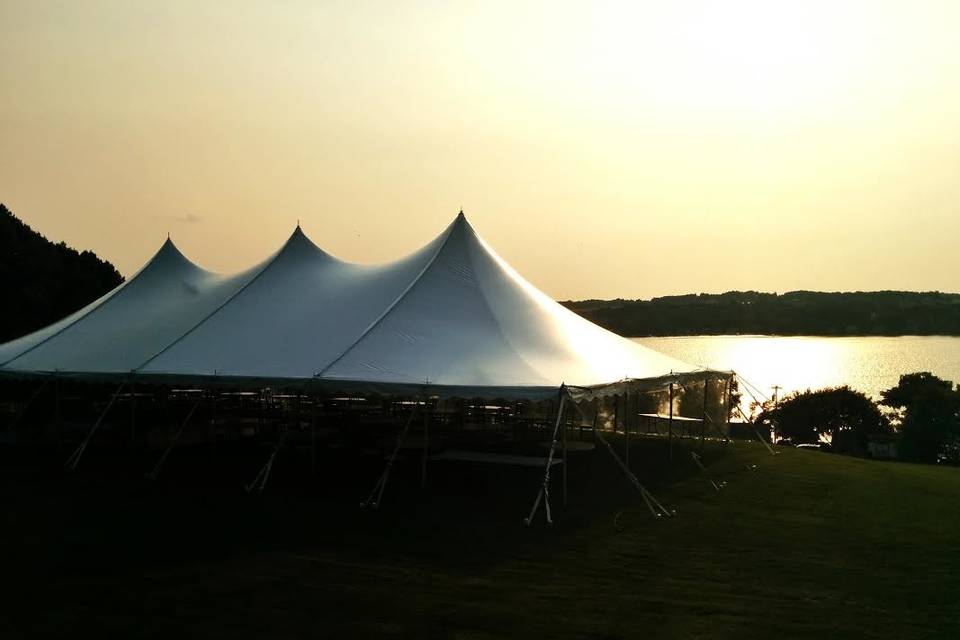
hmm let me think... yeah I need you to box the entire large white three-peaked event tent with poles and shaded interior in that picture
[0,212,733,521]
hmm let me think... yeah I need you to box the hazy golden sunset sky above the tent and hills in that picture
[0,0,960,299]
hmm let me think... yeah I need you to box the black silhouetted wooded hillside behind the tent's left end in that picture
[0,204,123,342]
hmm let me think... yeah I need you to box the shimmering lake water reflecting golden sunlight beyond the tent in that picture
[634,336,960,398]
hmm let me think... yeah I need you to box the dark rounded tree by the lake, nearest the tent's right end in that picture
[759,386,890,454]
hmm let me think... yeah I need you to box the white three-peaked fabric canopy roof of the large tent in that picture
[0,212,720,397]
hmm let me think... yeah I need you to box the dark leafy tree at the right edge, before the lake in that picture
[880,372,960,462]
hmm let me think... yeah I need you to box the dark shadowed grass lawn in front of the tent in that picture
[0,441,960,640]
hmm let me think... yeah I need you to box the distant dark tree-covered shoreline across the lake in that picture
[563,291,960,337]
